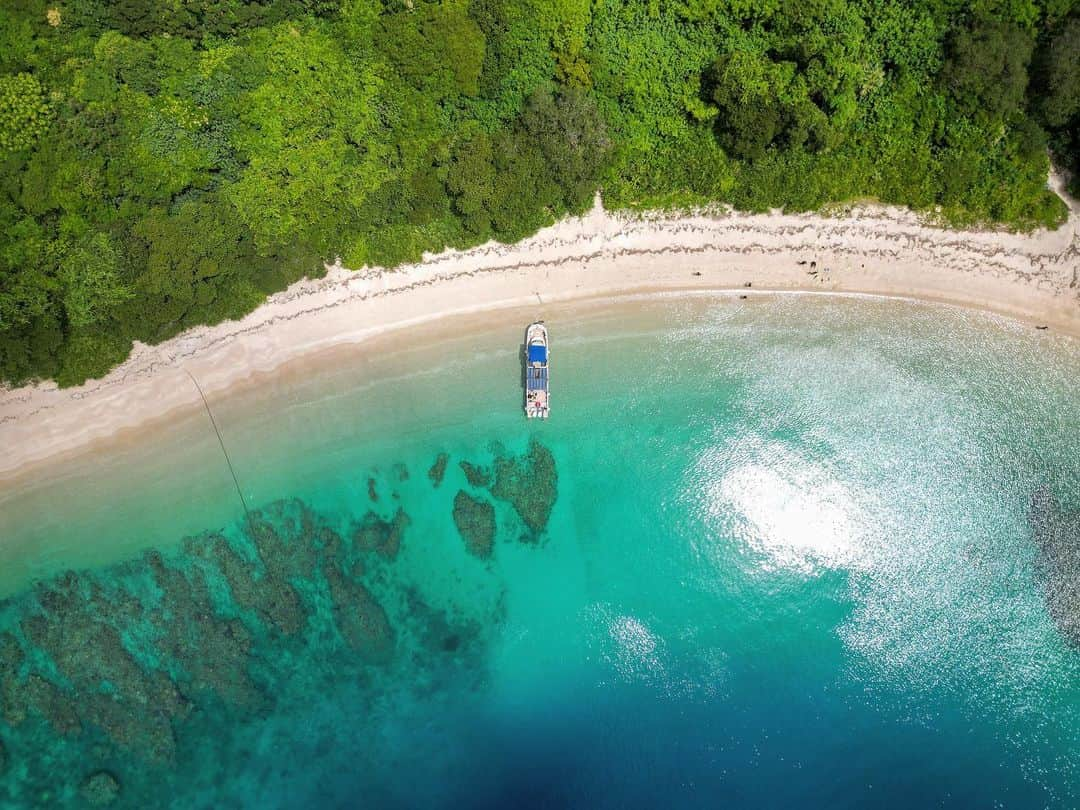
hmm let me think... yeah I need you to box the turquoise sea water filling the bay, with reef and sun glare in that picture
[0,296,1080,808]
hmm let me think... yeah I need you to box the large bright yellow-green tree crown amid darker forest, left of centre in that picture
[225,24,387,258]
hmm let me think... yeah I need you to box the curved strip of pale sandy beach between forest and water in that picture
[0,184,1080,482]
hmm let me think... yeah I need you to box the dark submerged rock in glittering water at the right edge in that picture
[1029,487,1080,647]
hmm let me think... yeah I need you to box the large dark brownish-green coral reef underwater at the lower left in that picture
[0,473,503,807]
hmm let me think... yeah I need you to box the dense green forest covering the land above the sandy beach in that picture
[0,0,1080,386]
